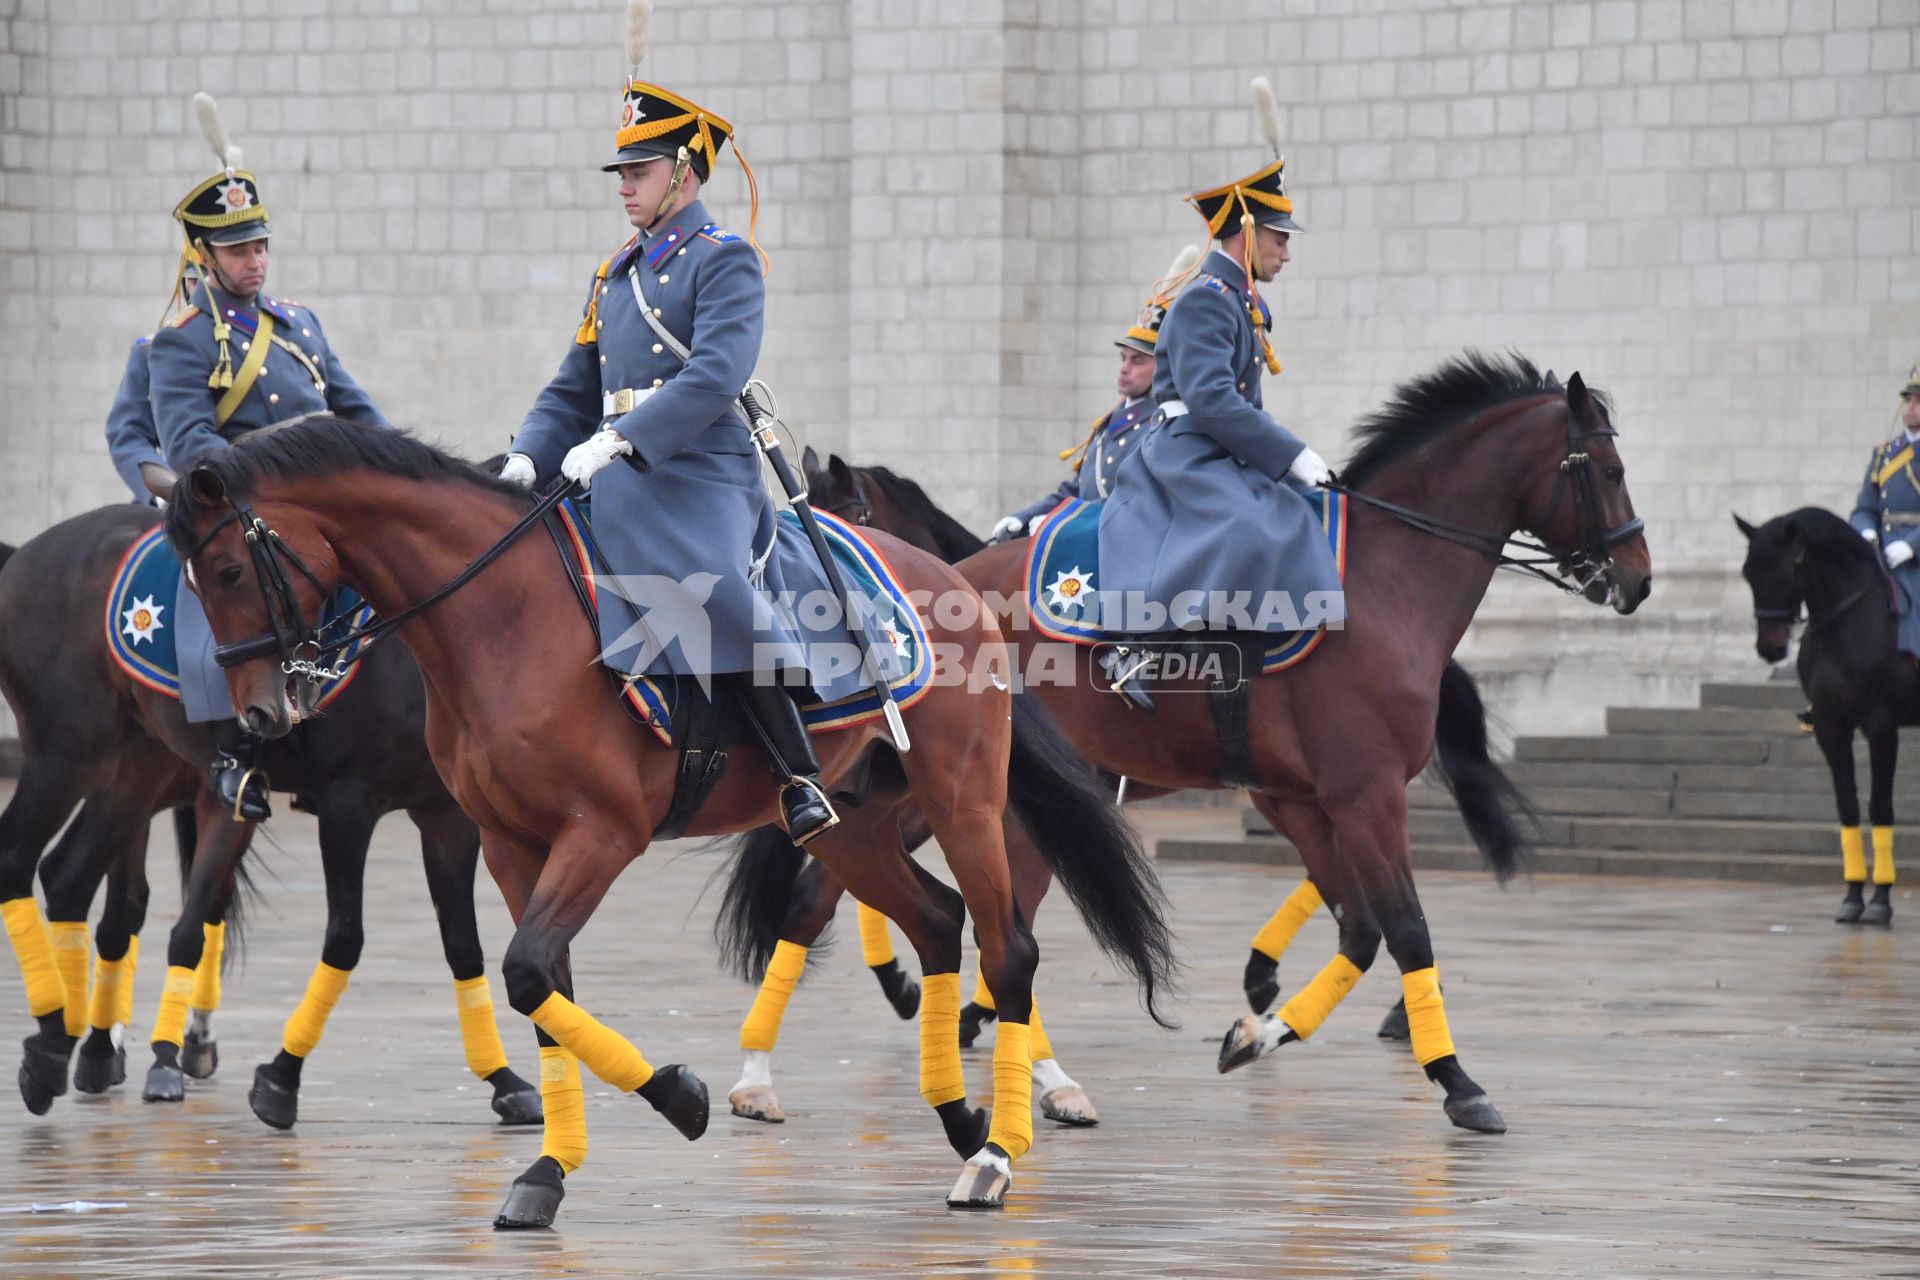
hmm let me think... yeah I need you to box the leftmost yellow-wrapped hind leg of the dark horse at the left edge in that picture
[0,752,86,1115]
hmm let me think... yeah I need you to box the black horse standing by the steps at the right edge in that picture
[1734,507,1920,925]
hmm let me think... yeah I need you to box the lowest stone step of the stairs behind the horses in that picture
[1156,837,1839,885]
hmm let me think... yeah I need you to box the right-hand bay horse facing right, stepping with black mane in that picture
[733,353,1653,1132]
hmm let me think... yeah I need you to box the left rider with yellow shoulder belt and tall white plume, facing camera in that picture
[148,94,388,821]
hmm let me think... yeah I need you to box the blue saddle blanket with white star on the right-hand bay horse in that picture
[1025,489,1348,676]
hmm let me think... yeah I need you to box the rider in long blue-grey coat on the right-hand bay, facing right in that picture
[1100,87,1344,710]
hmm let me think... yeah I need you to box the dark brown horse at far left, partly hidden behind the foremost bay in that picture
[0,505,541,1128]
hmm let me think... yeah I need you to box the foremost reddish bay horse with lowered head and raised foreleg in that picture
[167,416,1175,1228]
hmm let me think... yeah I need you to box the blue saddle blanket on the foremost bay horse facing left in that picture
[557,501,933,745]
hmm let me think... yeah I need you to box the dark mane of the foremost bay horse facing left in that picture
[167,415,532,545]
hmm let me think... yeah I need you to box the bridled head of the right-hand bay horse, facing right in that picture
[1521,374,1653,614]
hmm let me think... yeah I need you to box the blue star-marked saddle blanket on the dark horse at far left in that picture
[106,526,372,708]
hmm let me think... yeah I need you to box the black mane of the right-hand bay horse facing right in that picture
[1340,351,1589,489]
